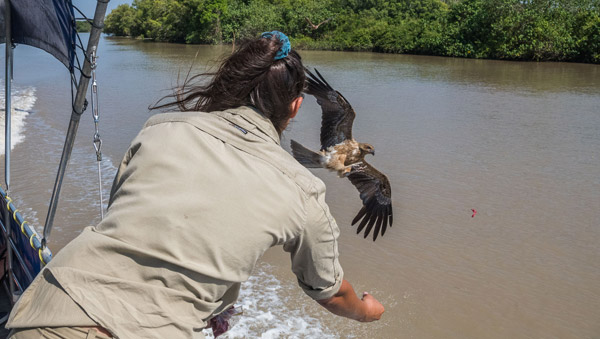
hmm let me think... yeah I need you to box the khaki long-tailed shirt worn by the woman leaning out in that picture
[7,107,343,338]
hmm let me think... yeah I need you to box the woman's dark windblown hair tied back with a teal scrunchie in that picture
[150,36,305,134]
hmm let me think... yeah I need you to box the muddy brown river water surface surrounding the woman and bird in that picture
[2,38,600,338]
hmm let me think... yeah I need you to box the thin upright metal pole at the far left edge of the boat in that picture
[4,0,16,303]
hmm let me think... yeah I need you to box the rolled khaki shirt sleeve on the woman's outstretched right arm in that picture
[283,179,344,300]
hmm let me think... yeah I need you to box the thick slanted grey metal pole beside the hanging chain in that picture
[42,0,109,248]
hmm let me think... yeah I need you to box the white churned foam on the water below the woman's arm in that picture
[203,264,338,339]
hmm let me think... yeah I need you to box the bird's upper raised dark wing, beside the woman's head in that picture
[305,69,356,150]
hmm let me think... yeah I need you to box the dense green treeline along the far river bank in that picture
[105,0,600,63]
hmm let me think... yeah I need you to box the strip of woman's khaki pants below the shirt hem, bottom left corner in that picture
[8,327,112,339]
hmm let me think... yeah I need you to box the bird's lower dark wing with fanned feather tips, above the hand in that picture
[348,160,393,241]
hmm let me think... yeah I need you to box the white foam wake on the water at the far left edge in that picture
[0,80,37,155]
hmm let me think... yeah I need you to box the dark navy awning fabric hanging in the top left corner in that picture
[0,0,76,71]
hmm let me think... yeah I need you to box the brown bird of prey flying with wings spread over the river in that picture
[291,69,393,241]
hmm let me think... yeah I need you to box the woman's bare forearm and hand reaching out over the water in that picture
[317,279,385,322]
